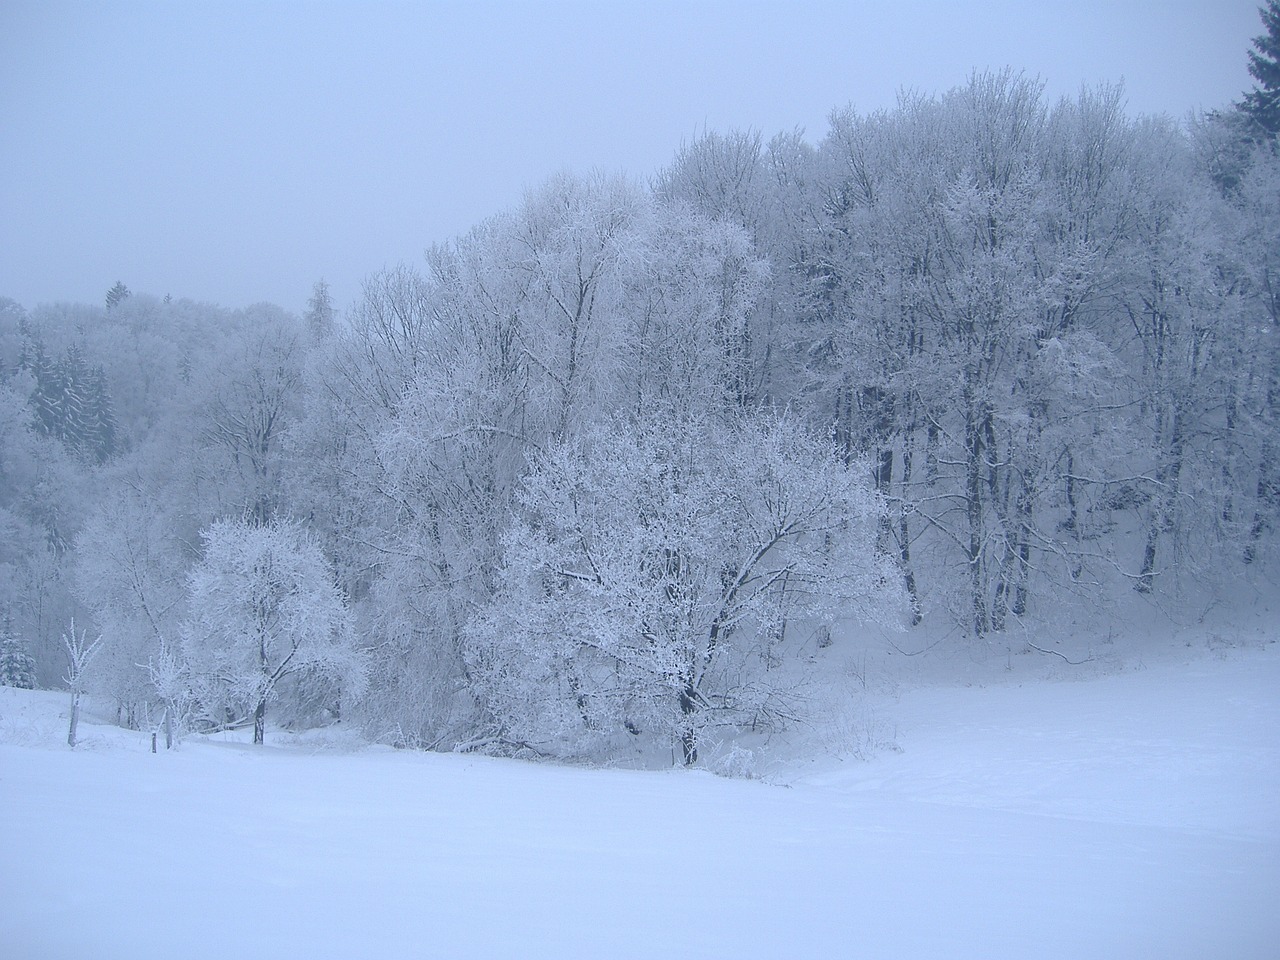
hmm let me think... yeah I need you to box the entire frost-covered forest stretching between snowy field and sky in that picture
[0,70,1280,764]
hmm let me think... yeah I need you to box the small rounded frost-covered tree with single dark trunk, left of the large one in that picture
[183,520,366,744]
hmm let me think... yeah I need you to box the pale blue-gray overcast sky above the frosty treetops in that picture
[0,0,1262,316]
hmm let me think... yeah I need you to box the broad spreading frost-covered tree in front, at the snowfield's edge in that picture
[467,419,902,764]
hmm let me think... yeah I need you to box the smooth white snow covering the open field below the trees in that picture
[0,643,1280,960]
